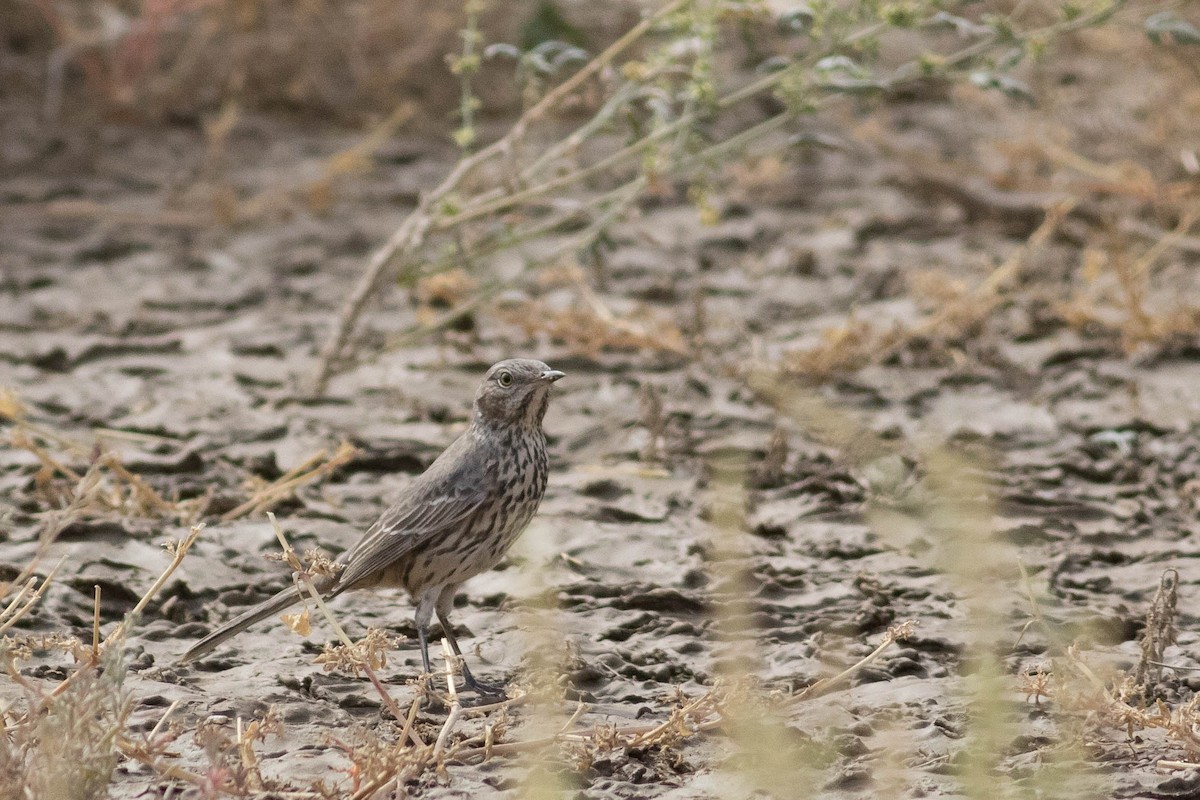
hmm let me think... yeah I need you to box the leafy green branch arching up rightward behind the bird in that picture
[310,0,1124,395]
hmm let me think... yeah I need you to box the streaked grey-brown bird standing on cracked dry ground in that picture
[179,359,564,697]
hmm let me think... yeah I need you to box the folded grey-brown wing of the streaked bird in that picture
[337,448,488,591]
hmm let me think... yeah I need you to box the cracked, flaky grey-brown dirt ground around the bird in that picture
[0,7,1200,800]
